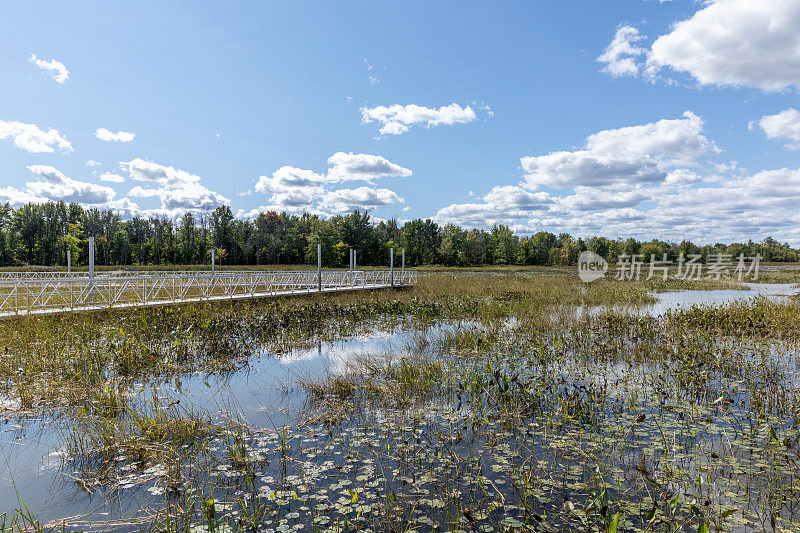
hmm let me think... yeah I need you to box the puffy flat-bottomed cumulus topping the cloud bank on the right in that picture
[520,111,719,189]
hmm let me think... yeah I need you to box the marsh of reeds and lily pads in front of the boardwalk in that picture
[0,270,800,533]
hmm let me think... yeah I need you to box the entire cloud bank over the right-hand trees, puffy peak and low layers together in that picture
[435,113,800,244]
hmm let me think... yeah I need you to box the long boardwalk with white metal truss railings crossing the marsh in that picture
[0,269,417,317]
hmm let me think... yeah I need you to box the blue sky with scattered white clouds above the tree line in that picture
[0,0,800,244]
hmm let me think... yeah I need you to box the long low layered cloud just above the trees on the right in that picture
[444,164,800,245]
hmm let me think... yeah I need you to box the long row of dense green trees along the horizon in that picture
[0,202,800,267]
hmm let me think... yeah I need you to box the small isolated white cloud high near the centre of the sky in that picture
[361,103,478,135]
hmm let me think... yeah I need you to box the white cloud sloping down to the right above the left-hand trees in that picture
[120,158,230,214]
